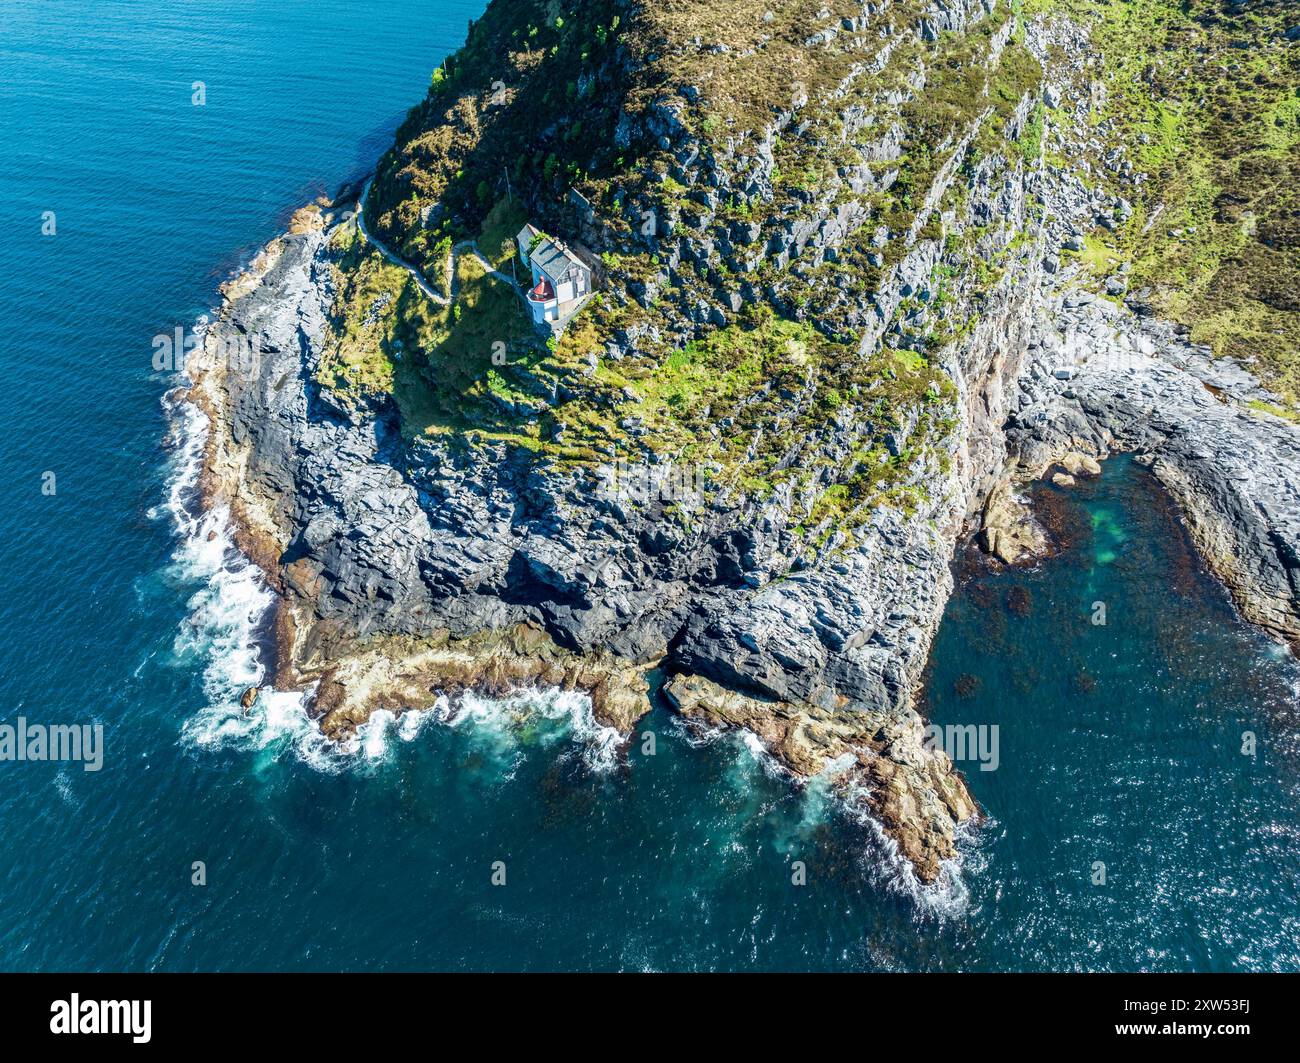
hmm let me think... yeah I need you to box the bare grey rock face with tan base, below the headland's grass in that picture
[191,191,1019,881]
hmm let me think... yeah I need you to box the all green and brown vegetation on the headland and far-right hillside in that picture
[322,0,1297,541]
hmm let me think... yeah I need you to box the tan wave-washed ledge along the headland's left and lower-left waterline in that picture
[186,218,653,739]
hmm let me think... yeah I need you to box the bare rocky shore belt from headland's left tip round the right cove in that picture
[187,4,1300,882]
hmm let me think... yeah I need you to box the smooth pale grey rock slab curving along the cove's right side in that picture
[1008,294,1300,646]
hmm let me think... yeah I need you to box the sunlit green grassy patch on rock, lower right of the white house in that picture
[556,307,956,530]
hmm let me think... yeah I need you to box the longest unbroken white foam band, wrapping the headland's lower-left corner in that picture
[155,384,621,772]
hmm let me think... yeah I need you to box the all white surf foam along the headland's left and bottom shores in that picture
[160,376,969,899]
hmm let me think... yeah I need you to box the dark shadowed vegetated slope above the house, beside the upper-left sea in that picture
[367,0,633,279]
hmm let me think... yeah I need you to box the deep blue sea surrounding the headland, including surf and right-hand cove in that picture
[0,0,1300,969]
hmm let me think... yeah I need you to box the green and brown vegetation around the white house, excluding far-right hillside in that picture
[321,0,1024,535]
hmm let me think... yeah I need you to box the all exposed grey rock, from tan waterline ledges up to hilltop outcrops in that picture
[180,0,1300,881]
